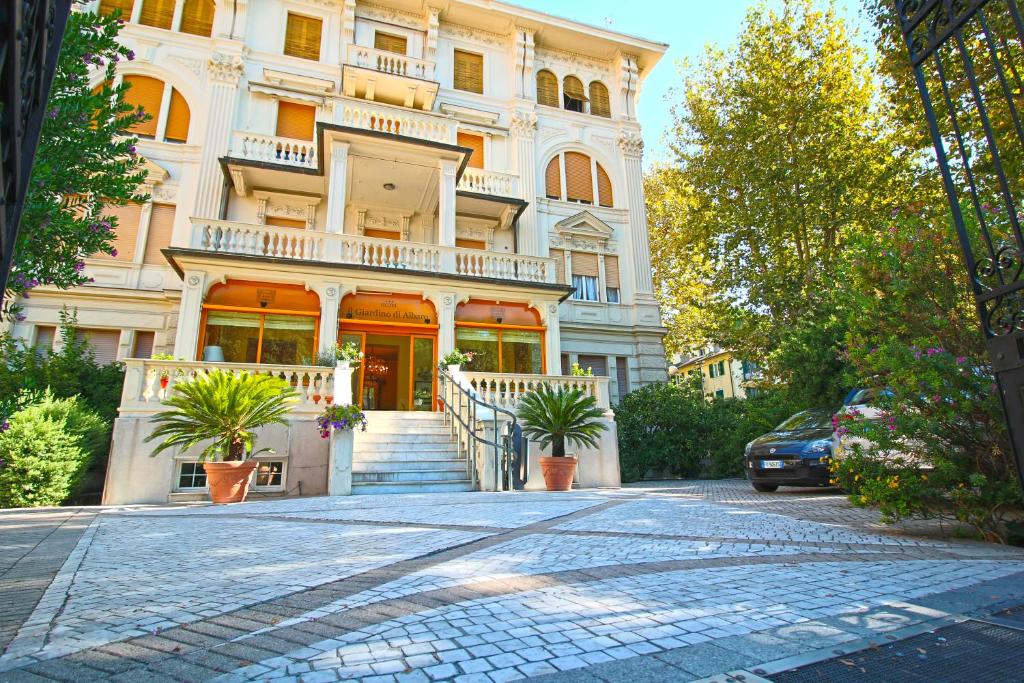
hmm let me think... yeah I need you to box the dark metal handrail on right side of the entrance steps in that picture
[437,368,516,490]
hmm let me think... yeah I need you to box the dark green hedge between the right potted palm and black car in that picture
[615,377,796,481]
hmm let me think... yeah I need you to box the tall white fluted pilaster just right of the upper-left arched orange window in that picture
[193,53,245,218]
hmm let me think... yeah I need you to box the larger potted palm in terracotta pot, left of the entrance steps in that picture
[145,370,298,503]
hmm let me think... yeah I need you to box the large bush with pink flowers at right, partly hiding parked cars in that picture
[833,340,1024,543]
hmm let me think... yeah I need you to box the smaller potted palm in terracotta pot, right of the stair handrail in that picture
[516,384,607,490]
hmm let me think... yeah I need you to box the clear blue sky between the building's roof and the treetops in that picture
[510,0,870,165]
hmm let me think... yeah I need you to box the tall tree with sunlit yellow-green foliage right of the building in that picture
[651,0,909,368]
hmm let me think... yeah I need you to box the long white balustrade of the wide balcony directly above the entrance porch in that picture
[191,218,555,283]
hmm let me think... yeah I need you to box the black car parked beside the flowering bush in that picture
[744,411,833,494]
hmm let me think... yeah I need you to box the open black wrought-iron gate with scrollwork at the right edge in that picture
[895,0,1024,485]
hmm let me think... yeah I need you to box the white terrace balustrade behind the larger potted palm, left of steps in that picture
[120,358,335,416]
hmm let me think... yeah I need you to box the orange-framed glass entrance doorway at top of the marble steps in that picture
[340,331,436,411]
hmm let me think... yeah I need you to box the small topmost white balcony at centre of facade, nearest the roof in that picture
[341,45,439,112]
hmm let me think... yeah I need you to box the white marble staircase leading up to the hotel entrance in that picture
[352,411,473,495]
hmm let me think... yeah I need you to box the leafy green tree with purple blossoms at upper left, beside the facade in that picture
[5,12,151,321]
